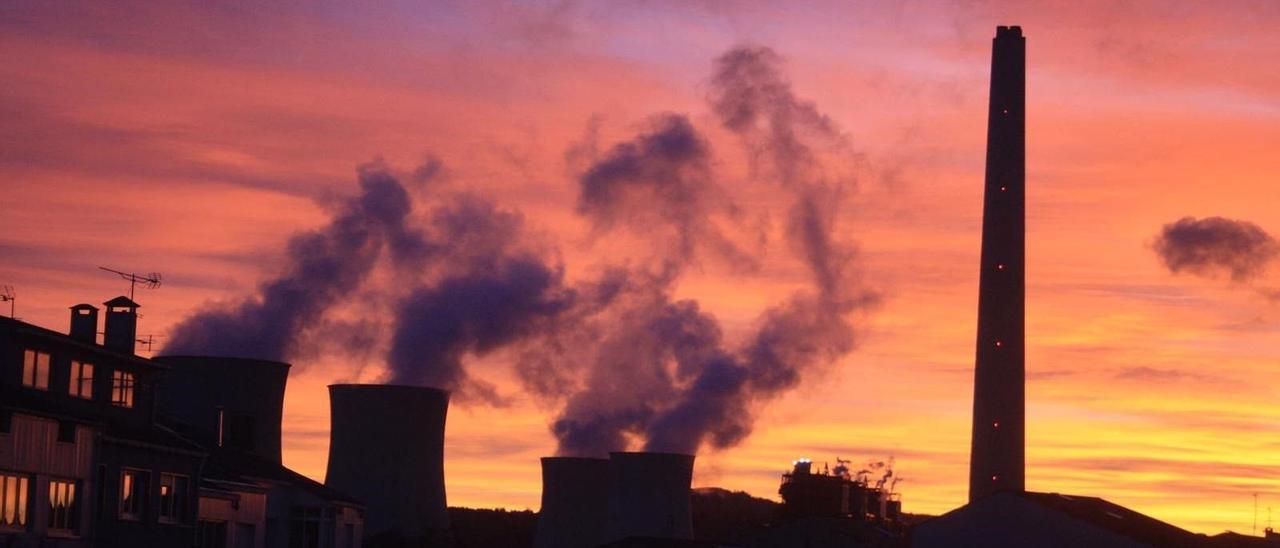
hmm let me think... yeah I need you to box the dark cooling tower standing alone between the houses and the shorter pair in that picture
[325,384,449,545]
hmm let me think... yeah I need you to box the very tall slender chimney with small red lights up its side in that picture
[969,27,1027,502]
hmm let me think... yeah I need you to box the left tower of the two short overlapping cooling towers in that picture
[534,457,609,548]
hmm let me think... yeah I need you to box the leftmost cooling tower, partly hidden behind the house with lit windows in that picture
[155,356,289,463]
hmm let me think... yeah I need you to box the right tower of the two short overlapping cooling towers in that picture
[605,452,694,542]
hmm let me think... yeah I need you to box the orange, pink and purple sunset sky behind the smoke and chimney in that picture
[0,1,1280,533]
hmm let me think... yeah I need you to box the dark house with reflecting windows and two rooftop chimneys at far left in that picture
[0,297,205,547]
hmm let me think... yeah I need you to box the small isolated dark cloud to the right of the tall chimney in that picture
[1153,216,1280,283]
